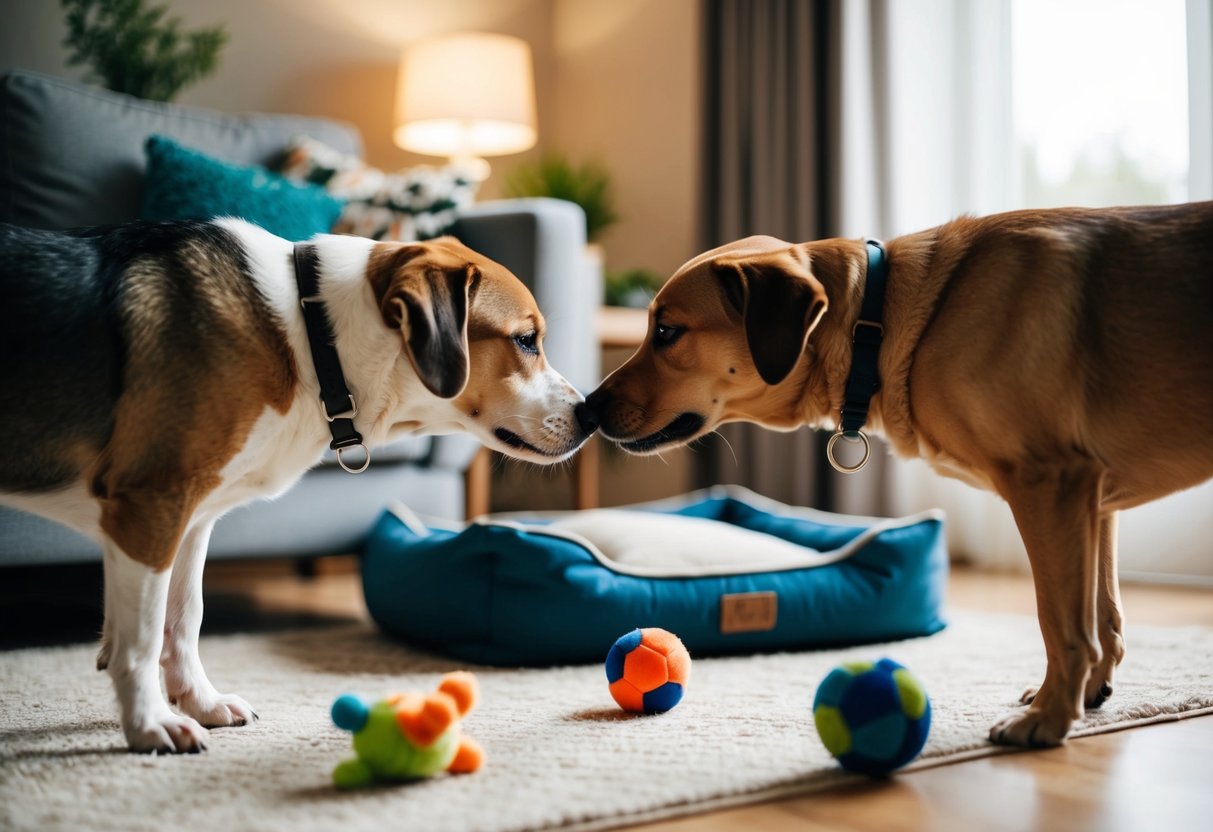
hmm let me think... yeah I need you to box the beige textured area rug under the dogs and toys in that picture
[0,615,1213,832]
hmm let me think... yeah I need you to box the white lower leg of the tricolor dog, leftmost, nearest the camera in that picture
[104,537,206,752]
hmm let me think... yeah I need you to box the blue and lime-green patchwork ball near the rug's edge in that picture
[813,659,930,776]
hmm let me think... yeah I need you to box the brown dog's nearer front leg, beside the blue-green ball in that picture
[990,463,1101,746]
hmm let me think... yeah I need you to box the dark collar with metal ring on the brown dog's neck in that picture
[826,240,889,474]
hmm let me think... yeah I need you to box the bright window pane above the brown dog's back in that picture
[1012,0,1189,207]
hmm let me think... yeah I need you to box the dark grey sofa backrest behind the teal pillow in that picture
[0,70,361,228]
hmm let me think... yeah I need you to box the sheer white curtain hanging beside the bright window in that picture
[832,0,1213,580]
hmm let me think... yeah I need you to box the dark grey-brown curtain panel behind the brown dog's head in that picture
[701,0,884,514]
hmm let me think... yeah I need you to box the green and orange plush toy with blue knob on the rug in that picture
[332,671,484,788]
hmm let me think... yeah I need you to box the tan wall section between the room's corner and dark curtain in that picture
[549,0,700,277]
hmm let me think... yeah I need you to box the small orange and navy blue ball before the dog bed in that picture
[607,627,690,713]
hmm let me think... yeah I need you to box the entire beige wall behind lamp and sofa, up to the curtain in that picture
[0,0,699,274]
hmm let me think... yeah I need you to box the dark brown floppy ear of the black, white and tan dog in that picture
[371,244,480,399]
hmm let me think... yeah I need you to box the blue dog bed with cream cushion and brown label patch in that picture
[363,486,947,666]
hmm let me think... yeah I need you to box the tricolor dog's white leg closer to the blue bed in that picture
[160,520,257,728]
